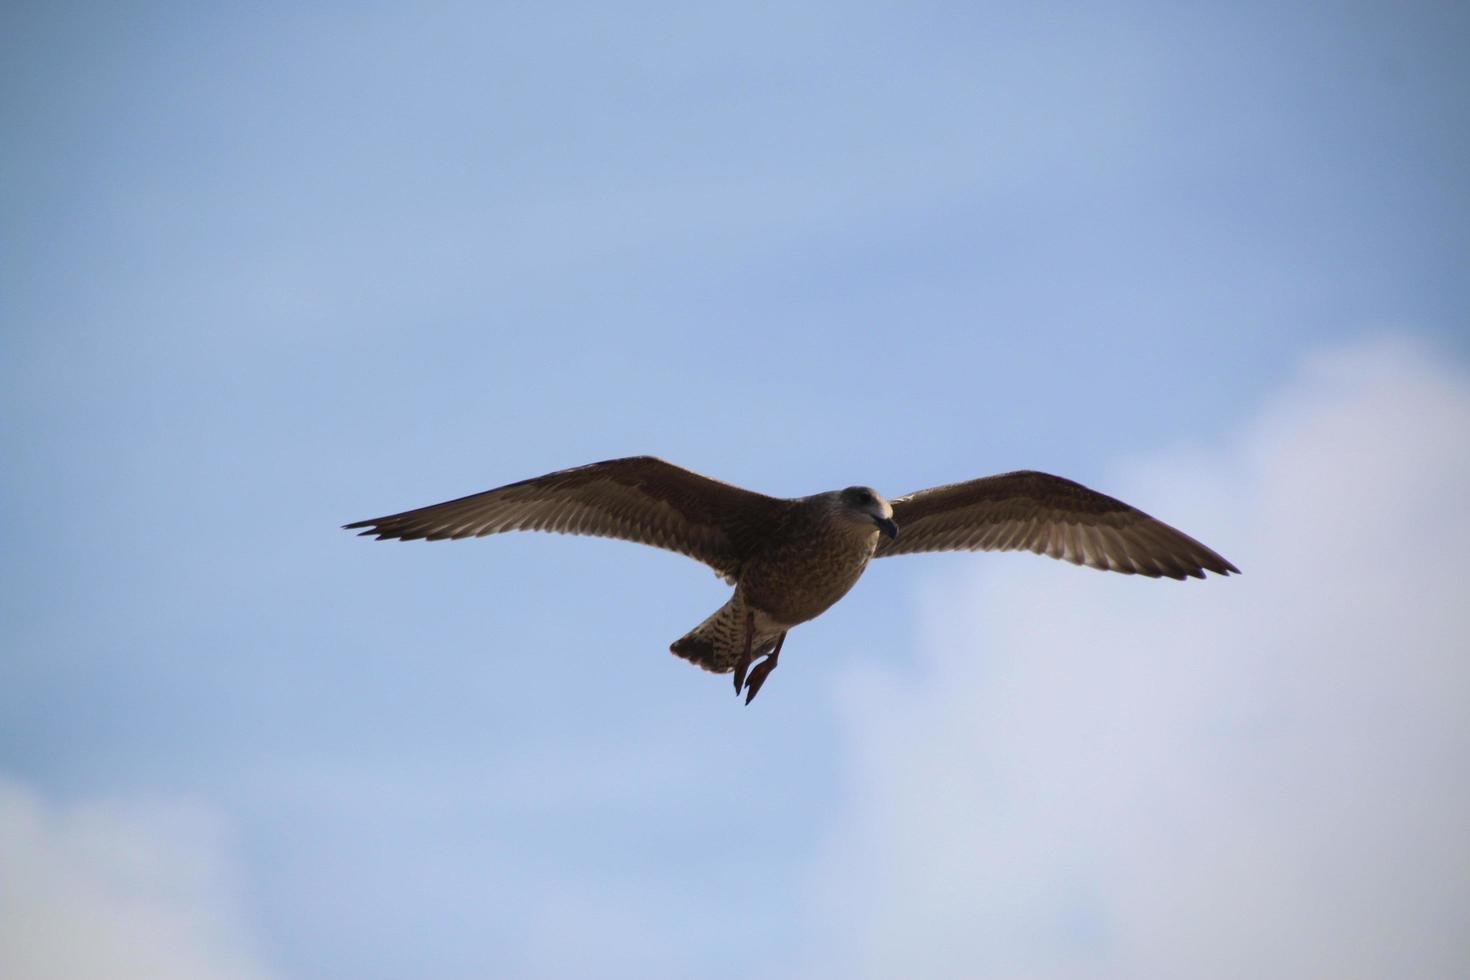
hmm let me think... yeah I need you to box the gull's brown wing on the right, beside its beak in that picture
[878,470,1241,579]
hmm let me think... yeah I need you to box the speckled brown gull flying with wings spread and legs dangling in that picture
[344,455,1239,704]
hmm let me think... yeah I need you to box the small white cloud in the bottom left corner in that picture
[0,777,277,980]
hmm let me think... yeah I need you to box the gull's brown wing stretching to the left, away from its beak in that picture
[344,455,788,579]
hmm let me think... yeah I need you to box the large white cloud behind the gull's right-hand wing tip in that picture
[806,341,1470,977]
